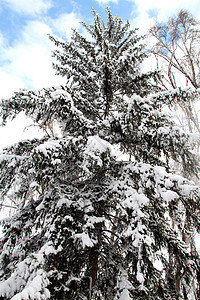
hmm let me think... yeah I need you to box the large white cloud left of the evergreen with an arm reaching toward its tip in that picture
[0,9,80,98]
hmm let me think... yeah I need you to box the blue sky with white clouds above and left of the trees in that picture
[0,0,200,148]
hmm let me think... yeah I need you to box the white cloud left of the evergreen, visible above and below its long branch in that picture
[0,16,67,150]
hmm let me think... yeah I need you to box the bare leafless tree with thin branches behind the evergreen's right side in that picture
[150,10,200,133]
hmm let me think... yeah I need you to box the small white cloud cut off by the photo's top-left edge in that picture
[3,0,52,15]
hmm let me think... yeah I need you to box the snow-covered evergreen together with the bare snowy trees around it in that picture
[0,8,200,300]
